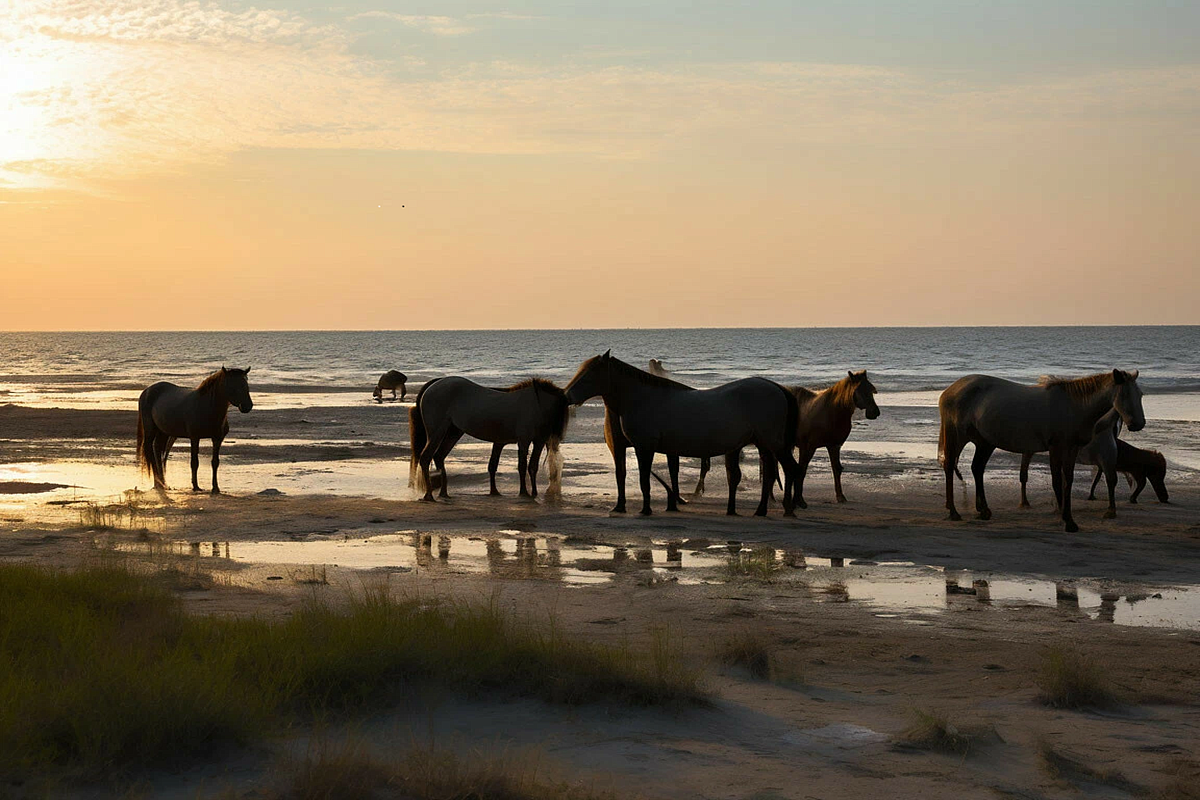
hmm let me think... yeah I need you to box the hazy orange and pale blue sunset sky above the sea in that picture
[0,0,1200,330]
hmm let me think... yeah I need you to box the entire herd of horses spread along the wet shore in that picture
[138,351,1168,533]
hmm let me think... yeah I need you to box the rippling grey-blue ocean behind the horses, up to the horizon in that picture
[0,326,1200,470]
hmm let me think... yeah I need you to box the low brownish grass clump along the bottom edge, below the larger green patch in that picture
[268,744,613,800]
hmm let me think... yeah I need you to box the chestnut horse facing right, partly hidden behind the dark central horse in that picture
[697,369,880,509]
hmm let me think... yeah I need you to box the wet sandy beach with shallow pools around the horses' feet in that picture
[0,403,1200,799]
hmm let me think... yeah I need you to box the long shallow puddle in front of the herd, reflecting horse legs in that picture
[97,530,1200,631]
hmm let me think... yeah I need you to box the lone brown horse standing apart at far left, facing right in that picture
[138,367,254,494]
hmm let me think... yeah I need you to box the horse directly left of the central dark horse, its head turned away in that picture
[408,377,569,500]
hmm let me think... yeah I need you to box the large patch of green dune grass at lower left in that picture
[0,565,704,776]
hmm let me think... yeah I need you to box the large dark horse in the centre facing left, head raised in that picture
[566,351,798,516]
